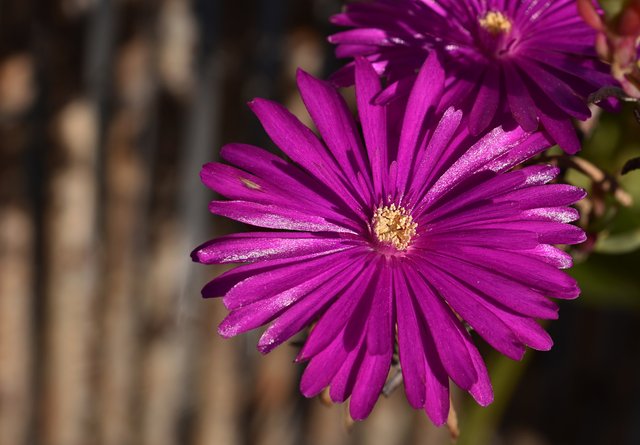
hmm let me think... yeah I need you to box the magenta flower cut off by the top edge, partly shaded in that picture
[329,0,616,153]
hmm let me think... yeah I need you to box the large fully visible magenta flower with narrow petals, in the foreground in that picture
[192,55,584,425]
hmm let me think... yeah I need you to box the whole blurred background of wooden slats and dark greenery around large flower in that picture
[0,0,640,445]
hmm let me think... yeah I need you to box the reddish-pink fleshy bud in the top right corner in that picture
[578,0,640,99]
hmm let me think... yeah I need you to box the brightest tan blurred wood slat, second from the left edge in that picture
[40,0,116,445]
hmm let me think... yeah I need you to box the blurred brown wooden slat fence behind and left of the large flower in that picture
[0,0,458,445]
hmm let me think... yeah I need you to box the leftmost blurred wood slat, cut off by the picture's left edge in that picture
[0,2,37,445]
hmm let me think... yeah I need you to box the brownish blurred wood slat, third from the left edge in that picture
[96,35,153,445]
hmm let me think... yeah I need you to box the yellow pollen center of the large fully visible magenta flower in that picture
[373,204,418,250]
